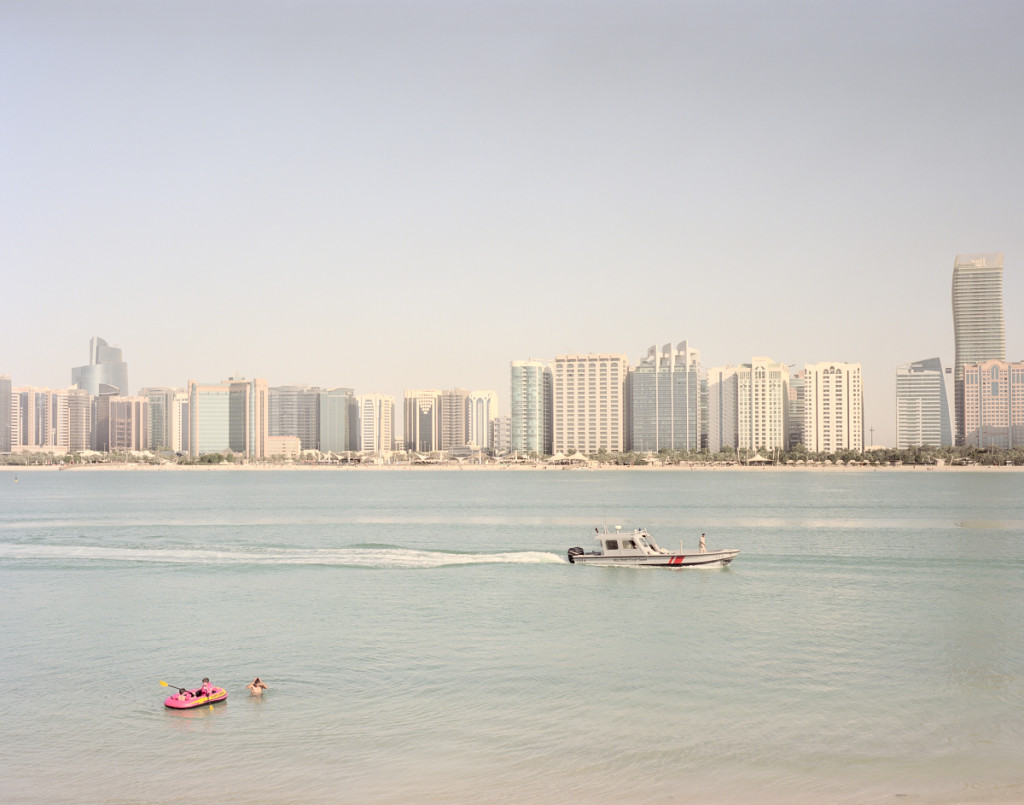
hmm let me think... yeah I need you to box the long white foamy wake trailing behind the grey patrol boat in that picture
[0,544,565,569]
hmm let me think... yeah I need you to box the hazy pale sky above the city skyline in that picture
[0,0,1024,444]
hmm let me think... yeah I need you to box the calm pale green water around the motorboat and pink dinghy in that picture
[0,470,1024,803]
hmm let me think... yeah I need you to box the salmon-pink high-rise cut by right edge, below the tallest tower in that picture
[964,359,1024,450]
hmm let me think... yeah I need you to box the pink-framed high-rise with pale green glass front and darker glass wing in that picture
[188,378,269,459]
